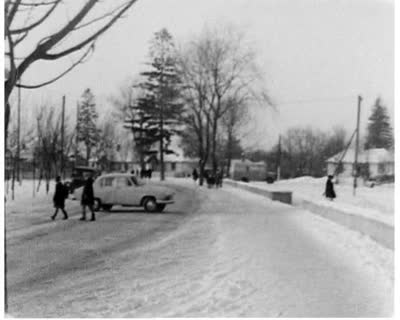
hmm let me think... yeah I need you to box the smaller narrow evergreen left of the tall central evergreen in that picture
[77,89,99,163]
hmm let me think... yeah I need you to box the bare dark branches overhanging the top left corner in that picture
[4,0,137,145]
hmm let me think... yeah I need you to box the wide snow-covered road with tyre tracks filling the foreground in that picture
[7,180,393,317]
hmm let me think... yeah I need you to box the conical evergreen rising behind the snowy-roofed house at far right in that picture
[365,98,393,149]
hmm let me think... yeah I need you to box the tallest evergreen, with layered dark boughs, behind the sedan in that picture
[141,29,183,180]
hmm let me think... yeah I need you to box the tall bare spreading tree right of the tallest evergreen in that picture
[180,27,272,180]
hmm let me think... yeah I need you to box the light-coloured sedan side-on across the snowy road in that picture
[74,173,174,212]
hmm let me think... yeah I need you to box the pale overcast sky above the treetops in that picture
[10,0,394,147]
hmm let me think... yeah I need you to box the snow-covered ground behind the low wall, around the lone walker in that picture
[251,176,394,226]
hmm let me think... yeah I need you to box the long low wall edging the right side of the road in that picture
[224,179,394,250]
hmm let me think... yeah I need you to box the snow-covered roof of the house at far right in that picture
[326,148,394,163]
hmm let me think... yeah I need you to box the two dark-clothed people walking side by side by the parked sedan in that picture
[51,174,96,221]
